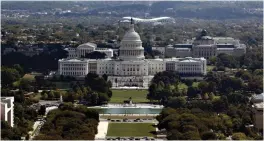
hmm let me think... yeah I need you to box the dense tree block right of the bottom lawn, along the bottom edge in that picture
[157,107,263,140]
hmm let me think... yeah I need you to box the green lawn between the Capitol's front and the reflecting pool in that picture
[110,90,149,103]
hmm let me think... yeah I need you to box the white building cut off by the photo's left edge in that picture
[1,97,14,127]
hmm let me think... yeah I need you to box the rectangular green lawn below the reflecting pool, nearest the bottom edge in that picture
[107,123,155,137]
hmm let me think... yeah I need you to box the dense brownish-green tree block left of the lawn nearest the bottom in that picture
[34,103,99,140]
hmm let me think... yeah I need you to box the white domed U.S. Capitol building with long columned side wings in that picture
[58,20,206,88]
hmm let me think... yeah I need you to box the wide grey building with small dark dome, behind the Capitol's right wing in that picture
[164,30,246,59]
